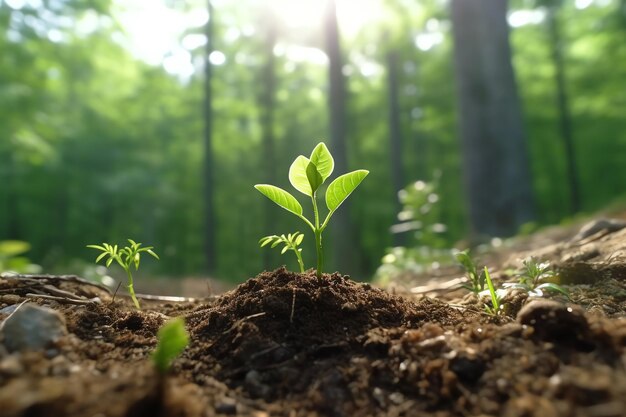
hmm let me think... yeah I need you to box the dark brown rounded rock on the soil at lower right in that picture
[517,300,593,351]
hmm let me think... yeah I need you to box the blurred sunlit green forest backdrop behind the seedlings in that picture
[0,0,626,281]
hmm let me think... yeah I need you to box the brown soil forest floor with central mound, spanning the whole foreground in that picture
[0,213,626,417]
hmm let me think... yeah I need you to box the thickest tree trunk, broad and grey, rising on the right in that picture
[452,0,534,236]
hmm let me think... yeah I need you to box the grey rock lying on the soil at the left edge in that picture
[0,304,67,352]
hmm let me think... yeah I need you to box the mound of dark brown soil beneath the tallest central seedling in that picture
[180,269,461,411]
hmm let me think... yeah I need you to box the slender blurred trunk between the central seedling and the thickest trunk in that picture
[387,50,406,246]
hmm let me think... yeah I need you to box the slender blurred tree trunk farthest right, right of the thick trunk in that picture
[547,7,580,214]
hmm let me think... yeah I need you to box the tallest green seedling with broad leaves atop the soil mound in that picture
[254,143,369,278]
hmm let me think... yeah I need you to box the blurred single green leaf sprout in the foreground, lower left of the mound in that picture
[152,317,189,375]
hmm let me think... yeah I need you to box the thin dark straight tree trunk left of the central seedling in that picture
[203,0,217,274]
